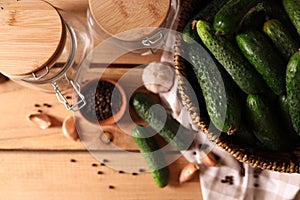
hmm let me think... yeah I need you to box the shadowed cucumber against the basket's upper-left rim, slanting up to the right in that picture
[182,0,228,43]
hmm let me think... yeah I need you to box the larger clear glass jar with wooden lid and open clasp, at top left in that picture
[0,0,93,111]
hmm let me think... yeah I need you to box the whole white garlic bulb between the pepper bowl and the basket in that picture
[142,62,175,94]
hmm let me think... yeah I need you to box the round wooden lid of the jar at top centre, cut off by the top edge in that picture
[89,0,171,41]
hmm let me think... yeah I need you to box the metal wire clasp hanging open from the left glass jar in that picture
[52,80,86,112]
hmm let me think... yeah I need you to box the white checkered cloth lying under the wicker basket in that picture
[160,80,300,200]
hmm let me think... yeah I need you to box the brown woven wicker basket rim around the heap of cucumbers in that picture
[174,0,300,173]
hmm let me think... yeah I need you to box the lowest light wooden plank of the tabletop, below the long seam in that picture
[0,151,200,200]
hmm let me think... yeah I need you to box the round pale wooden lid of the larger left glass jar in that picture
[0,0,65,76]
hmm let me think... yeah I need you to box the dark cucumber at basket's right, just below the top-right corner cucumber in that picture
[263,19,300,61]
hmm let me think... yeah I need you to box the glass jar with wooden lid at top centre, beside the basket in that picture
[87,0,179,55]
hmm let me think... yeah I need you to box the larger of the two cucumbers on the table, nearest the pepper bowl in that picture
[131,92,195,150]
